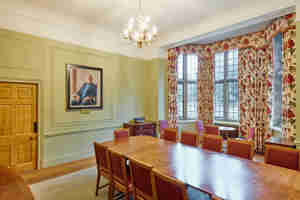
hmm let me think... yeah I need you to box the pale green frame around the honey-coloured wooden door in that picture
[0,77,42,170]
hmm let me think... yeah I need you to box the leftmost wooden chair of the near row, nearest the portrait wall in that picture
[94,142,111,196]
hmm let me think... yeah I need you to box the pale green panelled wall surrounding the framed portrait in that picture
[0,29,149,166]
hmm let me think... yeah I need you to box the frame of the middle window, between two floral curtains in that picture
[213,49,240,123]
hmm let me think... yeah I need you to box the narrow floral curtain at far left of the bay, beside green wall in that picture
[168,49,178,128]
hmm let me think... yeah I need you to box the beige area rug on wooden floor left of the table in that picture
[30,167,108,200]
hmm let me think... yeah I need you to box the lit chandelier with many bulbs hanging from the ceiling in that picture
[121,0,157,48]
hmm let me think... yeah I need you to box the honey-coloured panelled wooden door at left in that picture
[0,82,37,171]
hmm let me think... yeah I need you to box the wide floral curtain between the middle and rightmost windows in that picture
[239,47,273,151]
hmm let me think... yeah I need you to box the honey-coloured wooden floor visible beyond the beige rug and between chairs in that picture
[22,154,264,184]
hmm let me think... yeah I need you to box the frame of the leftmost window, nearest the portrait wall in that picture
[177,54,199,120]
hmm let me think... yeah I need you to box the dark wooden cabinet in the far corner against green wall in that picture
[123,121,156,137]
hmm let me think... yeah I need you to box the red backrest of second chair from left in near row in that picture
[108,150,129,186]
